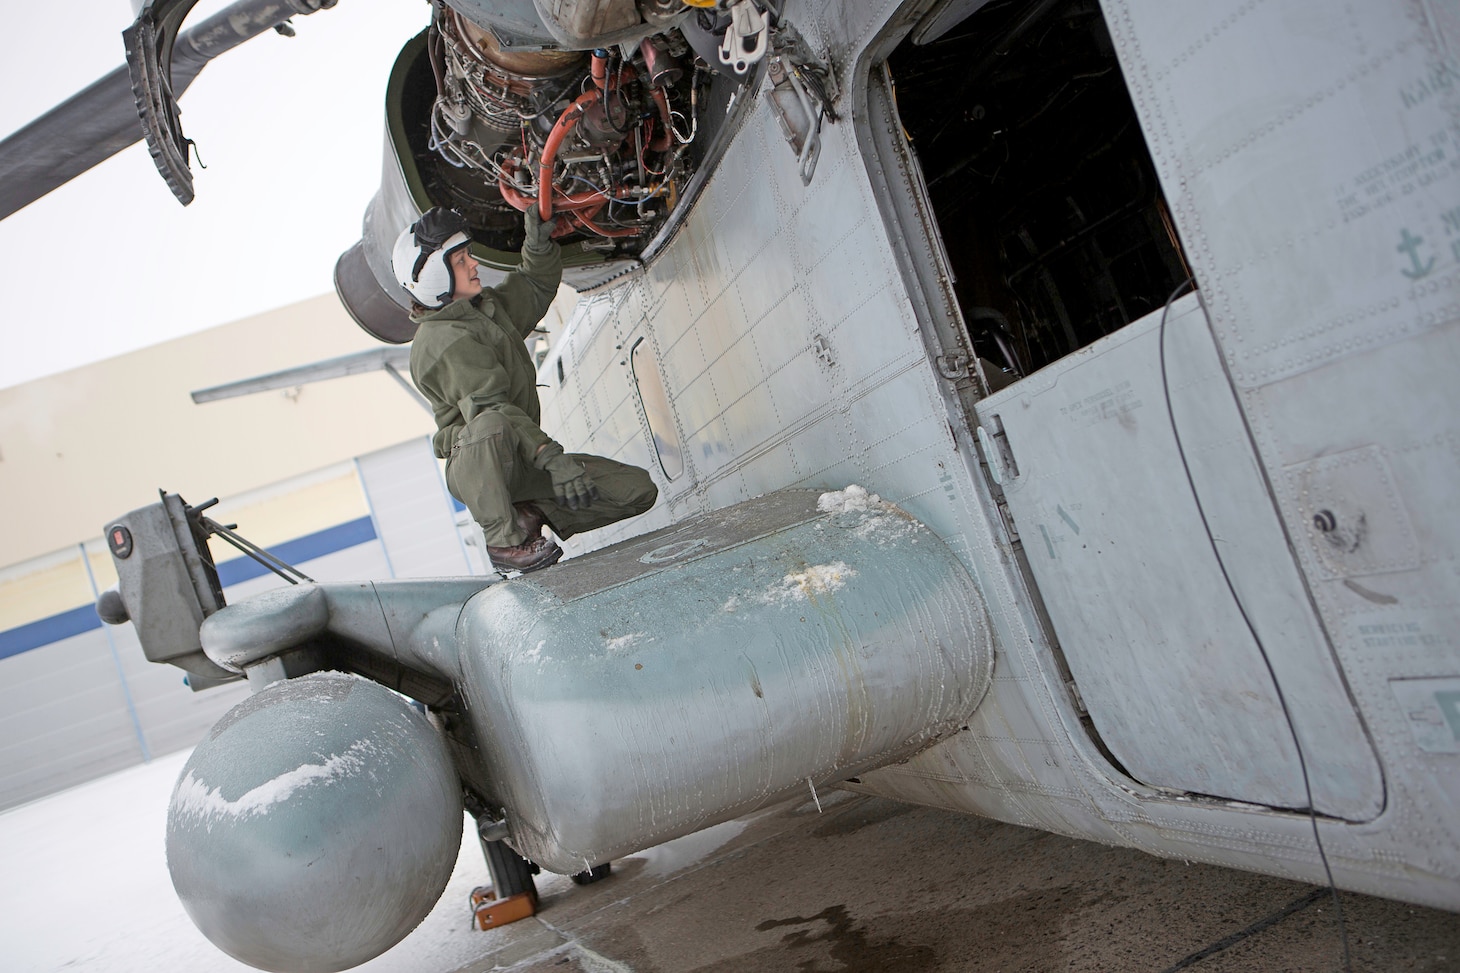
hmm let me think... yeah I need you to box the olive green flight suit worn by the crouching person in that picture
[410,244,658,548]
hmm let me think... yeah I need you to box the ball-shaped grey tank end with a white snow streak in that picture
[166,672,461,973]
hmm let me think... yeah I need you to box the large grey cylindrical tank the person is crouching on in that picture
[418,489,993,874]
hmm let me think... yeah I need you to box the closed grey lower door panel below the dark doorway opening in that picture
[977,295,1384,821]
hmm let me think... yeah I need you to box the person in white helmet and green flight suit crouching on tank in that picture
[391,206,658,573]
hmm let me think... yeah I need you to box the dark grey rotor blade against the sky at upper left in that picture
[0,0,333,219]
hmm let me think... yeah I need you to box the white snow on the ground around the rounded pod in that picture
[0,751,488,973]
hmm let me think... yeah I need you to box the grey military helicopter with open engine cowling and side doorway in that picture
[5,0,1460,970]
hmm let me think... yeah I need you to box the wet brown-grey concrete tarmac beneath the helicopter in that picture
[457,792,1460,973]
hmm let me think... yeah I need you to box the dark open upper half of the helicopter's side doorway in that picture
[888,0,1188,377]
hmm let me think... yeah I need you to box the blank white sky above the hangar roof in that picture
[0,0,429,389]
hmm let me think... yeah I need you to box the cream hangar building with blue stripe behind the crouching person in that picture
[0,289,577,809]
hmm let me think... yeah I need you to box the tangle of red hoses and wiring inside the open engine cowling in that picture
[416,0,712,250]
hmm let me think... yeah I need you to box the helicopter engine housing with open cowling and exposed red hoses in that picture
[334,0,817,343]
